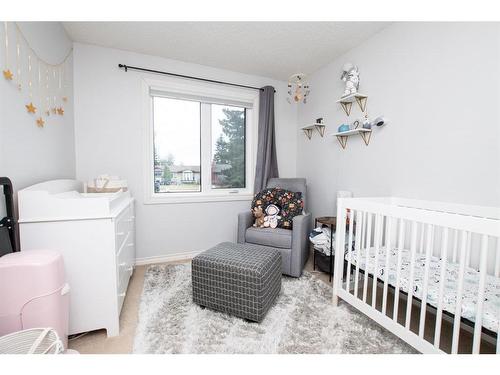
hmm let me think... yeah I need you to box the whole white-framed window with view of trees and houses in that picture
[145,77,258,203]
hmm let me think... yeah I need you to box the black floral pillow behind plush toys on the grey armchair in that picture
[252,187,304,229]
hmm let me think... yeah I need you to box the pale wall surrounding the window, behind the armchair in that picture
[74,43,297,258]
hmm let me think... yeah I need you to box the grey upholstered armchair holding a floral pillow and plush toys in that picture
[238,178,312,277]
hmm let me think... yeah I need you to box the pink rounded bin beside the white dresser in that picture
[0,250,69,348]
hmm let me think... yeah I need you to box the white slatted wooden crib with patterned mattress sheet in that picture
[333,198,500,354]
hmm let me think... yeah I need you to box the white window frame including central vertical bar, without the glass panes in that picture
[142,77,259,204]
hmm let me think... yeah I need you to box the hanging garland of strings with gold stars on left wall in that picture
[2,22,73,128]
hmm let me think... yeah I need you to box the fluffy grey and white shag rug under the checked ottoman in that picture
[133,264,415,354]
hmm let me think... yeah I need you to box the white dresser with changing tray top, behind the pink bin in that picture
[18,180,135,336]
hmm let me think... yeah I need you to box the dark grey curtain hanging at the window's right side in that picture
[254,86,279,193]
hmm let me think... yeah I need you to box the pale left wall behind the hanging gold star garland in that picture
[0,22,75,216]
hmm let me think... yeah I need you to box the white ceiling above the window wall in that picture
[63,22,388,80]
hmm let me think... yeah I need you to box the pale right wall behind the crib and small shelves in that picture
[297,23,500,220]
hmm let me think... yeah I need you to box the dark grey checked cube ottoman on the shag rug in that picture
[191,242,281,322]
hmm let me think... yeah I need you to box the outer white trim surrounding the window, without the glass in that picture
[142,77,259,204]
